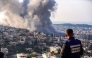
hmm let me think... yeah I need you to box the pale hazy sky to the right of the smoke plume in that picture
[51,0,92,24]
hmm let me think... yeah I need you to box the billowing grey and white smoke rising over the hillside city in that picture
[0,0,56,33]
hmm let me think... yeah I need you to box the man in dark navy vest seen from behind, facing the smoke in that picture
[61,29,83,58]
